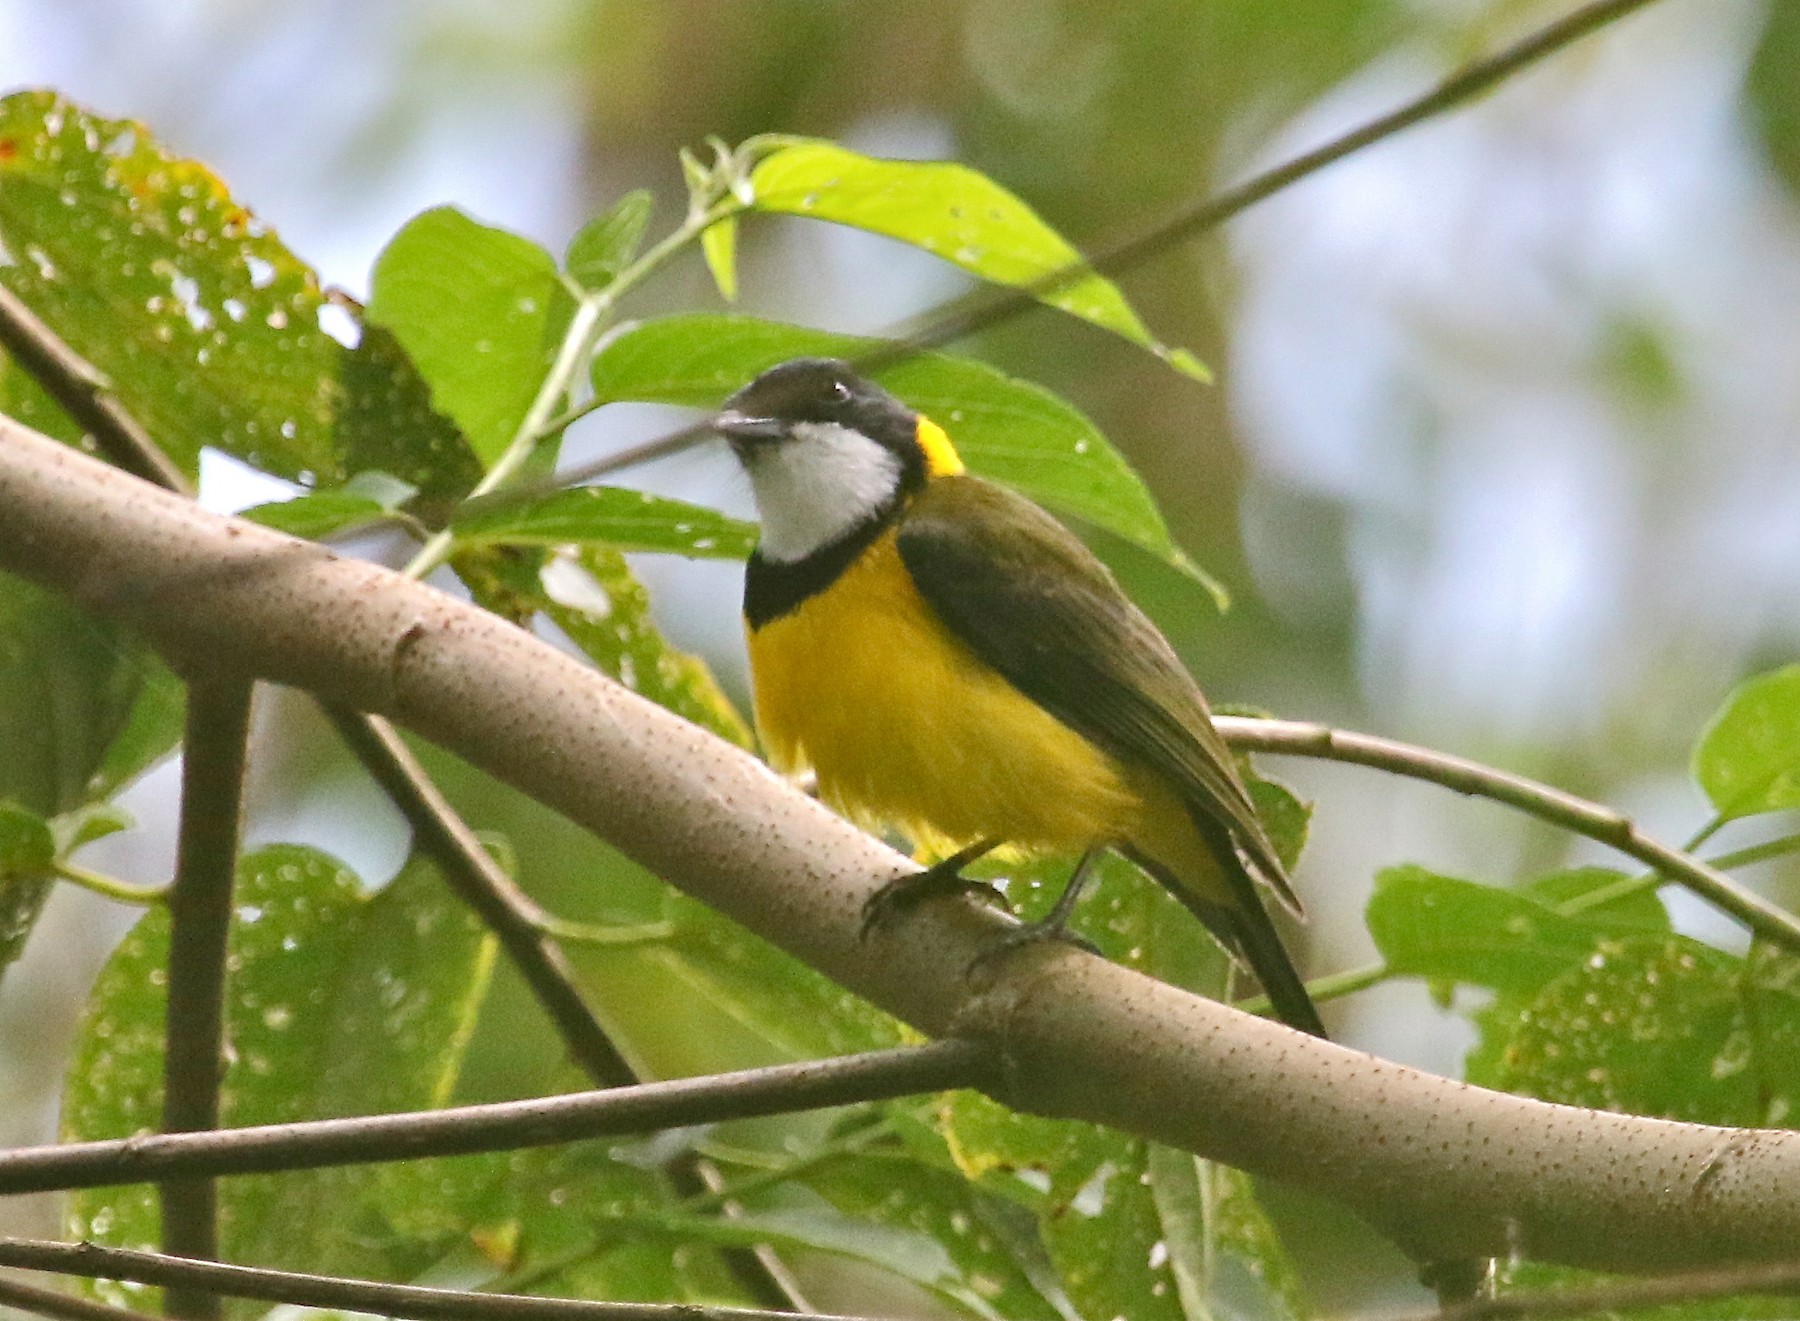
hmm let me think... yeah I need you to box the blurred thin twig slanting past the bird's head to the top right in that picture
[514,0,1654,500]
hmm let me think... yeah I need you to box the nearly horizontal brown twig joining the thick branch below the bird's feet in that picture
[0,1038,995,1195]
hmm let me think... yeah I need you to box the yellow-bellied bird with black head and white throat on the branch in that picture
[713,358,1325,1037]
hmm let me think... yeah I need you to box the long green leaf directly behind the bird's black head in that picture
[594,315,1192,571]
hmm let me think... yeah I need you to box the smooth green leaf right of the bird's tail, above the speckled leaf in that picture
[1366,866,1629,992]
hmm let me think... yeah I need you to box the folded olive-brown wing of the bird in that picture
[898,477,1300,912]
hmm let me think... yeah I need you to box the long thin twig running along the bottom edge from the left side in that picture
[0,1238,866,1321]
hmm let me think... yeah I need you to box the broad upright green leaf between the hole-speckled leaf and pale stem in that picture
[369,207,574,464]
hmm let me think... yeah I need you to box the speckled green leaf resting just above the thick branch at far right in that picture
[1492,936,1800,1127]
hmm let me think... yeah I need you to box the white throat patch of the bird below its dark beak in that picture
[743,421,900,563]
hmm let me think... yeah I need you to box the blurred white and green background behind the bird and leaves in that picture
[0,0,1800,1317]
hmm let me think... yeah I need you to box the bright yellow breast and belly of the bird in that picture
[749,533,1143,851]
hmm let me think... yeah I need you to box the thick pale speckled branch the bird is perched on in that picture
[0,419,1800,1271]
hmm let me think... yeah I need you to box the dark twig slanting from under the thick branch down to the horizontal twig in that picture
[326,707,637,1087]
